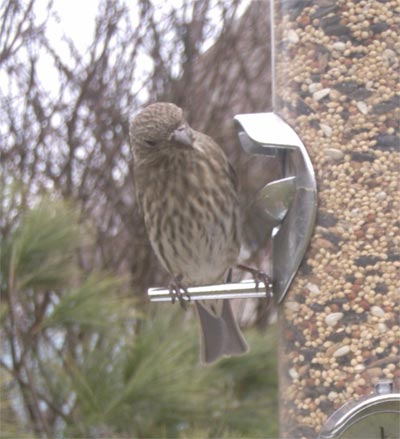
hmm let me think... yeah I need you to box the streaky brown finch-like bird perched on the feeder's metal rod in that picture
[129,102,270,364]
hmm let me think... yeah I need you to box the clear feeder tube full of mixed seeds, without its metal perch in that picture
[271,0,400,439]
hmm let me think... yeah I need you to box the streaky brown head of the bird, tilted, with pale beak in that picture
[129,102,193,159]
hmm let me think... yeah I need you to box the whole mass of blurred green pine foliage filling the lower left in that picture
[0,193,277,439]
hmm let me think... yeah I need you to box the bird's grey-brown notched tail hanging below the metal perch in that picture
[195,299,248,363]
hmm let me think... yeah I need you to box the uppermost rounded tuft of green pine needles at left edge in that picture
[1,199,83,291]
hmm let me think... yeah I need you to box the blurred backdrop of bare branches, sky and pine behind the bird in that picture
[0,0,278,438]
